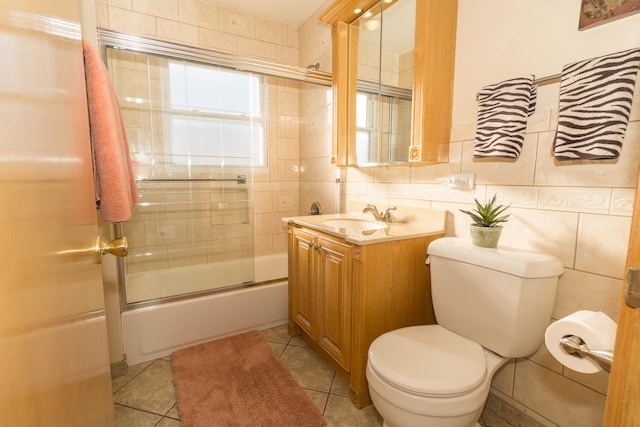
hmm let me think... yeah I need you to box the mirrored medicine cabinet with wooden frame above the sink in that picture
[319,0,458,166]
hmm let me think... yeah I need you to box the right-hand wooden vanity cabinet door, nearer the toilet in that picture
[316,237,351,371]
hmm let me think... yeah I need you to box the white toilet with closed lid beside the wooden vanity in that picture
[366,237,564,427]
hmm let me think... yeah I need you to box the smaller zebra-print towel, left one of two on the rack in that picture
[473,75,537,159]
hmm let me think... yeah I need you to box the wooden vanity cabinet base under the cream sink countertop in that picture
[288,223,442,408]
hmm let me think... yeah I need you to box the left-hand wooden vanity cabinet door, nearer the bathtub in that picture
[289,228,316,337]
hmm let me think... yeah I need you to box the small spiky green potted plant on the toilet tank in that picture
[460,194,511,248]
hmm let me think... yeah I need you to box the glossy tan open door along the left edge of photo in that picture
[0,0,114,427]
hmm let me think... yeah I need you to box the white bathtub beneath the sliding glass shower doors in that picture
[122,253,288,365]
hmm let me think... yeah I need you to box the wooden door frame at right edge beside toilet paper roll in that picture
[604,167,640,427]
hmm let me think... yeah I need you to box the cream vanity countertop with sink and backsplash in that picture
[282,209,446,245]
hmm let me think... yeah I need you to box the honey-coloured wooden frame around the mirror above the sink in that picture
[318,0,458,167]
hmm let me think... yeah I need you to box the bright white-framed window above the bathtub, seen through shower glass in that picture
[165,60,267,167]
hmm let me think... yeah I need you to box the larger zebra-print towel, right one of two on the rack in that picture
[554,49,640,160]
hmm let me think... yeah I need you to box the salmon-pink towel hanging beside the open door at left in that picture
[82,40,138,223]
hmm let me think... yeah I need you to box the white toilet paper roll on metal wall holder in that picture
[544,310,617,374]
